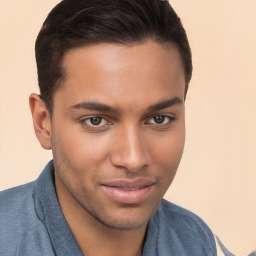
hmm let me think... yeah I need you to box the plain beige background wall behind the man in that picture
[0,0,256,255]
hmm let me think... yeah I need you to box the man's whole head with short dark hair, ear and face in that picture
[30,0,192,230]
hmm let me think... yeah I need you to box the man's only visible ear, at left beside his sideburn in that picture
[29,93,52,149]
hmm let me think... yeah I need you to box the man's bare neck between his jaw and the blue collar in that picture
[55,173,147,256]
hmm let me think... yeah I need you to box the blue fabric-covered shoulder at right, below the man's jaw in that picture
[152,200,217,255]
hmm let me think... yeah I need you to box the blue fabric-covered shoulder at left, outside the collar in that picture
[0,182,54,255]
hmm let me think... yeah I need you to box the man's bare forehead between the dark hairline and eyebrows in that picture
[55,41,185,110]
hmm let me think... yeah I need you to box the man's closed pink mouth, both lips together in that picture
[102,179,155,204]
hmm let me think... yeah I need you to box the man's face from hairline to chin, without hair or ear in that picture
[51,41,185,229]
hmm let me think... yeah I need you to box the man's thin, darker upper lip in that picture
[102,178,155,188]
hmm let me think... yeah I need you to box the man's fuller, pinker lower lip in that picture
[103,185,152,204]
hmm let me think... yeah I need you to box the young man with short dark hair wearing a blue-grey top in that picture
[0,0,234,256]
